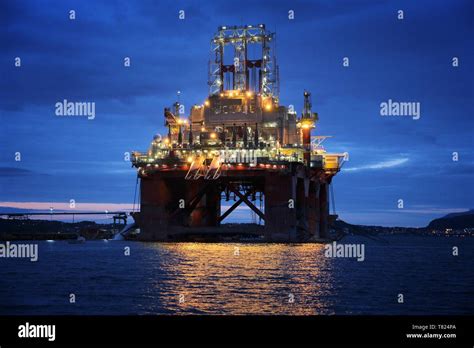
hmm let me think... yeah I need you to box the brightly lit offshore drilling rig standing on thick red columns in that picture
[132,24,345,242]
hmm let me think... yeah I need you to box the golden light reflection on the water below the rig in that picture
[146,243,332,314]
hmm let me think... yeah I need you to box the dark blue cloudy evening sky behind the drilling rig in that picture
[0,0,474,226]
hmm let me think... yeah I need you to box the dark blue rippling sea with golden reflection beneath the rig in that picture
[0,234,474,315]
